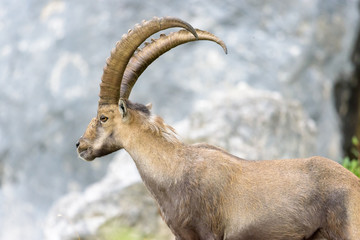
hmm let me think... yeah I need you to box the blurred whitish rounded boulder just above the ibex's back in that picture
[177,83,317,160]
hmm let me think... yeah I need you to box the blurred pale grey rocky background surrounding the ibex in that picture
[0,0,360,240]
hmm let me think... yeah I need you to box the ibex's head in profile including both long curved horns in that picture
[76,17,227,161]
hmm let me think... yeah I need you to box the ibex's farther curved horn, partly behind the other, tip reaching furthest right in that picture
[120,29,227,99]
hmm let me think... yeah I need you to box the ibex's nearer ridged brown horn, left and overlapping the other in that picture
[99,17,197,106]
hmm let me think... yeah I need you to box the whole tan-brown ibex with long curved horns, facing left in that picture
[76,17,360,240]
